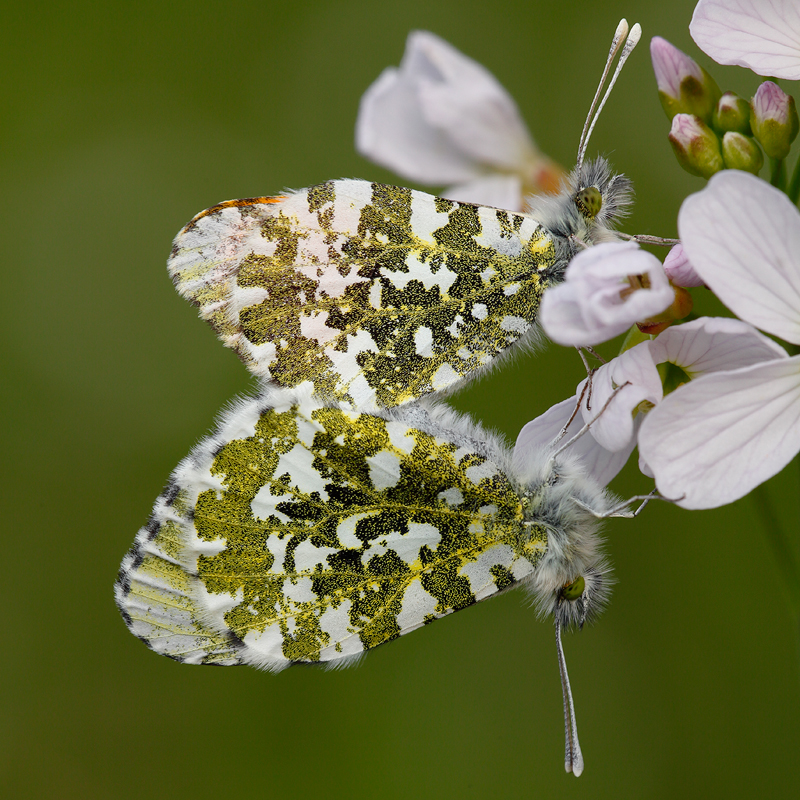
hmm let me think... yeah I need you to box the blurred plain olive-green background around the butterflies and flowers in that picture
[0,0,800,800]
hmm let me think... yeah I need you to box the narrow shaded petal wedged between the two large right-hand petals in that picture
[648,317,789,378]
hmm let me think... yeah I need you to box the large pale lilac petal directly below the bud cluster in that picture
[678,170,800,343]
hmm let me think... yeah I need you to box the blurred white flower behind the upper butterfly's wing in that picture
[356,31,563,211]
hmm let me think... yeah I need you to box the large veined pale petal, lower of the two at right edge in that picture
[639,356,800,508]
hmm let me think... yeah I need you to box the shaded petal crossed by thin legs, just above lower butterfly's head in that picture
[513,397,635,486]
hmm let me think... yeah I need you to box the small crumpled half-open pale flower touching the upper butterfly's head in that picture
[539,242,675,346]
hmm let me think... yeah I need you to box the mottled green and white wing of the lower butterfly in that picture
[117,391,547,670]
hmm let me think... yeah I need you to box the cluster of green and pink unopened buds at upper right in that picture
[650,36,799,178]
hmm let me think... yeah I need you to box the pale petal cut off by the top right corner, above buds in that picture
[689,0,800,81]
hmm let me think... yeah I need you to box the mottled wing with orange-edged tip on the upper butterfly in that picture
[169,180,568,411]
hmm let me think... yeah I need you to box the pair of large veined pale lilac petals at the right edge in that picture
[639,170,800,508]
